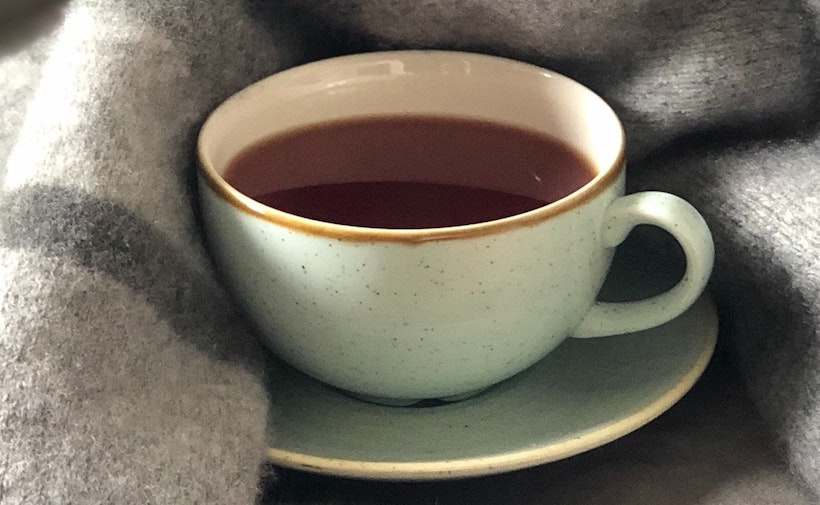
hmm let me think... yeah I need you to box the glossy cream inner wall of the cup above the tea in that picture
[199,51,624,220]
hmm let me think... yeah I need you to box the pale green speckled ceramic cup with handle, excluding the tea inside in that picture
[199,51,713,403]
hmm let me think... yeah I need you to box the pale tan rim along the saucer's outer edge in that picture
[266,300,718,481]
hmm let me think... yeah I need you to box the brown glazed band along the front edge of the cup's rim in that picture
[197,58,626,244]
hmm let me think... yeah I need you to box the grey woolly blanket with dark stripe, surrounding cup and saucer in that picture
[0,0,820,505]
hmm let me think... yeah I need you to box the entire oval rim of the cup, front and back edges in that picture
[197,50,626,244]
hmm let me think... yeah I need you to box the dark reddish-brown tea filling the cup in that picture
[225,116,595,229]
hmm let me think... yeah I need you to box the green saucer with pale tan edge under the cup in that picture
[267,238,718,480]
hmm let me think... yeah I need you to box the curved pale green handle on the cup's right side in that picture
[573,191,715,338]
